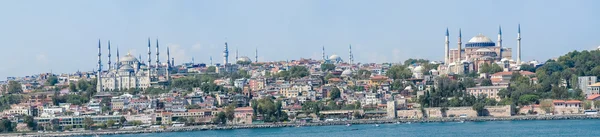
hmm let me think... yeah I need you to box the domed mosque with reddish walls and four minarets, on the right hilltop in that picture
[439,25,522,74]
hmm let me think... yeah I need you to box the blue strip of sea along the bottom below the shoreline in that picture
[104,120,600,137]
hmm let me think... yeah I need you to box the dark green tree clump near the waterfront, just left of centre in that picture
[251,98,288,122]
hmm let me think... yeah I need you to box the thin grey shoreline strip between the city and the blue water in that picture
[5,115,600,137]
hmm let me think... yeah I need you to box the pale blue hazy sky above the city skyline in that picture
[0,0,600,80]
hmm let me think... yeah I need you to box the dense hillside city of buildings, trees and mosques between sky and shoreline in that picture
[0,25,600,133]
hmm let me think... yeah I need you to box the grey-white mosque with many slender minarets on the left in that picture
[97,39,174,92]
